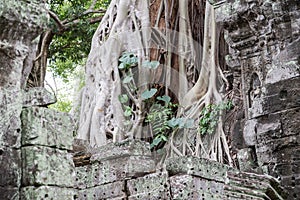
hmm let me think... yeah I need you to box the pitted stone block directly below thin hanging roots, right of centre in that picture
[166,156,234,183]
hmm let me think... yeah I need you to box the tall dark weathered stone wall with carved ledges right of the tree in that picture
[214,0,300,199]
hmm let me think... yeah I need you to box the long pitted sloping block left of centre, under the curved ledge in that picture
[76,156,155,188]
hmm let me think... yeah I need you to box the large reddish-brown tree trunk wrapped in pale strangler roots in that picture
[78,0,230,162]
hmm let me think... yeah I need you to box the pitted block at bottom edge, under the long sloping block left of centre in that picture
[76,181,126,200]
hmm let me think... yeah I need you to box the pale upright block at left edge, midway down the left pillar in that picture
[0,89,22,148]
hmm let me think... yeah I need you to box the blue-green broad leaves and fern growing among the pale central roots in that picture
[118,52,194,148]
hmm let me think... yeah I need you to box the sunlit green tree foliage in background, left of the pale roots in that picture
[48,0,111,81]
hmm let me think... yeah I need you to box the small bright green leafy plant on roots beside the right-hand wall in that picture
[199,101,232,135]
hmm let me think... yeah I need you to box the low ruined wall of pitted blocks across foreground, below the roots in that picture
[4,96,286,200]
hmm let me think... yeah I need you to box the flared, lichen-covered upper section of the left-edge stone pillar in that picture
[0,0,48,89]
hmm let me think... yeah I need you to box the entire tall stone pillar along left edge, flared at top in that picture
[0,0,47,199]
